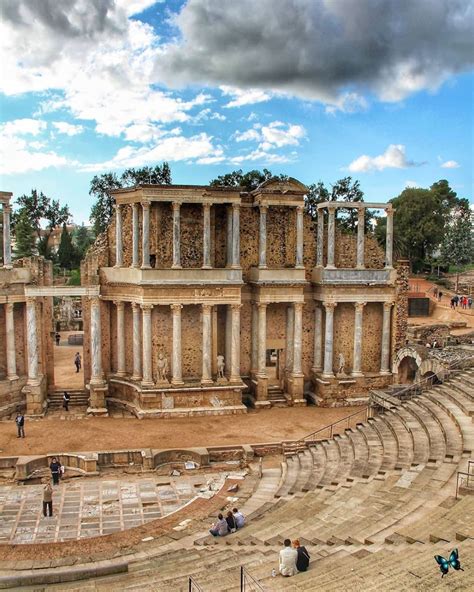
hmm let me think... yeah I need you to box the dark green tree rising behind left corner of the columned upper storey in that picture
[89,162,171,236]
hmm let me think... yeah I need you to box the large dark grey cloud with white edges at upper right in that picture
[155,0,474,103]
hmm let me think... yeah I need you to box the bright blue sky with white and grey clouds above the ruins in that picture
[0,0,474,222]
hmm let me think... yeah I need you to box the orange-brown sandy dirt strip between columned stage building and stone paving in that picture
[0,407,363,456]
